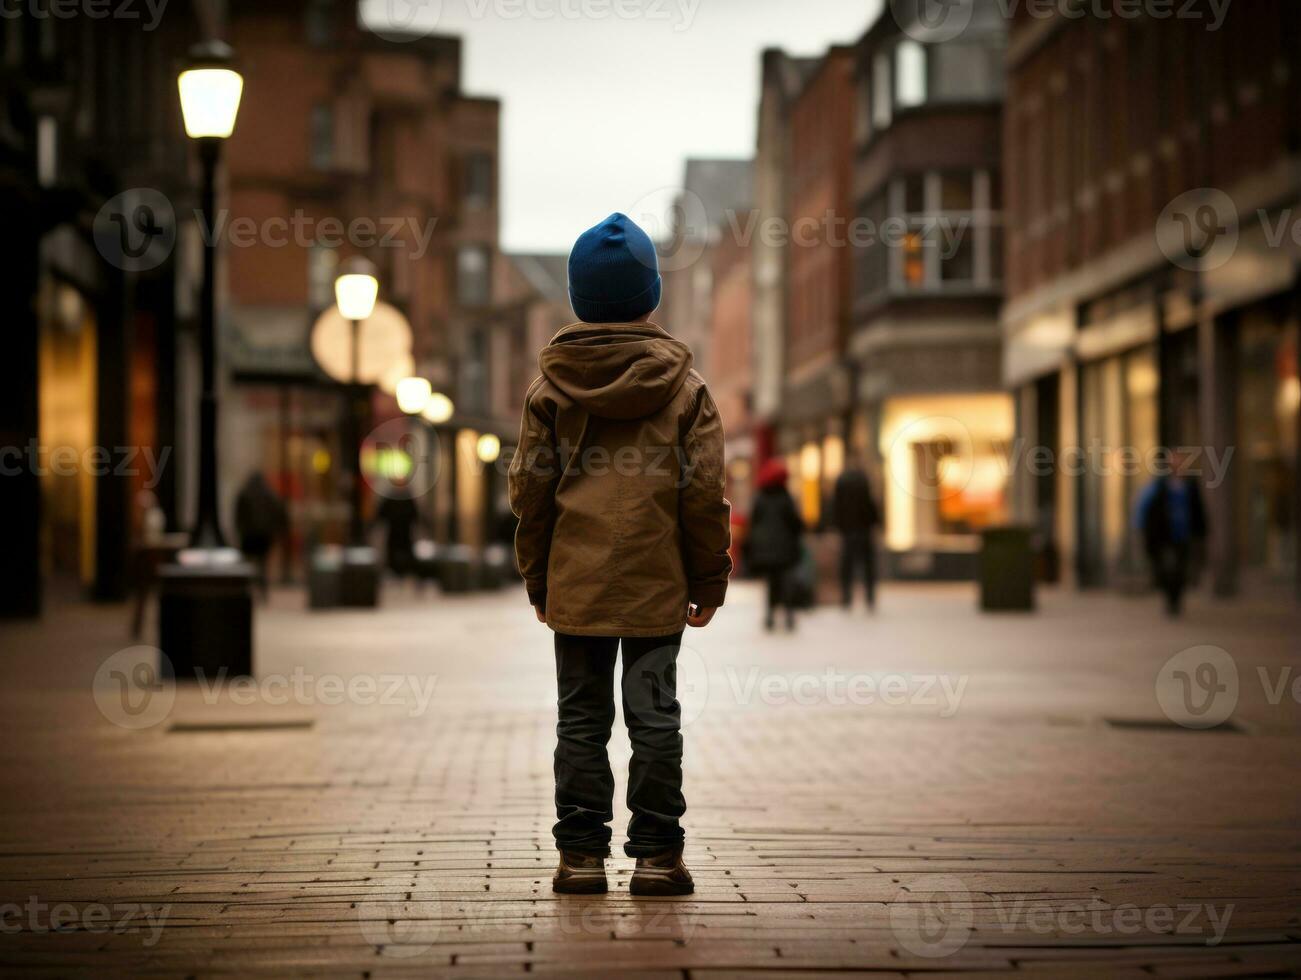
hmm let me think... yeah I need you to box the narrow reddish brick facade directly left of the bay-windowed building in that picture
[774,47,855,526]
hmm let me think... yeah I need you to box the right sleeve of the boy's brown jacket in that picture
[678,385,731,606]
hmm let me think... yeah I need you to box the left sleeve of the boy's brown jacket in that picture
[507,379,559,608]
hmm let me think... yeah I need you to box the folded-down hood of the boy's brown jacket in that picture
[537,323,691,419]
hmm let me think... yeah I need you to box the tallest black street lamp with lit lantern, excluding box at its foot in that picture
[177,40,243,549]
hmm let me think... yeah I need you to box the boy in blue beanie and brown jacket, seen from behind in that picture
[510,213,731,895]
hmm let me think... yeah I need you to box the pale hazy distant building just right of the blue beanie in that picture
[653,159,752,379]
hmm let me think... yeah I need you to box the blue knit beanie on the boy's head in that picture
[569,212,660,323]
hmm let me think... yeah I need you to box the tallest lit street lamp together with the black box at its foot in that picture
[159,40,252,679]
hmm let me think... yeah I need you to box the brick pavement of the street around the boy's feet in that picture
[0,586,1301,980]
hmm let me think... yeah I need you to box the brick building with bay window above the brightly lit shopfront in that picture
[843,0,1013,578]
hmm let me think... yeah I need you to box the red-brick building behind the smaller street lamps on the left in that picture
[221,0,505,570]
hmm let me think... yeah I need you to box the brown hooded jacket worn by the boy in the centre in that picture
[510,323,731,636]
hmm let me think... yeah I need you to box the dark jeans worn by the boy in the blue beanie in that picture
[552,633,687,858]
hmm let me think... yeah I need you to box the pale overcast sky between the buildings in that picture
[367,0,881,251]
